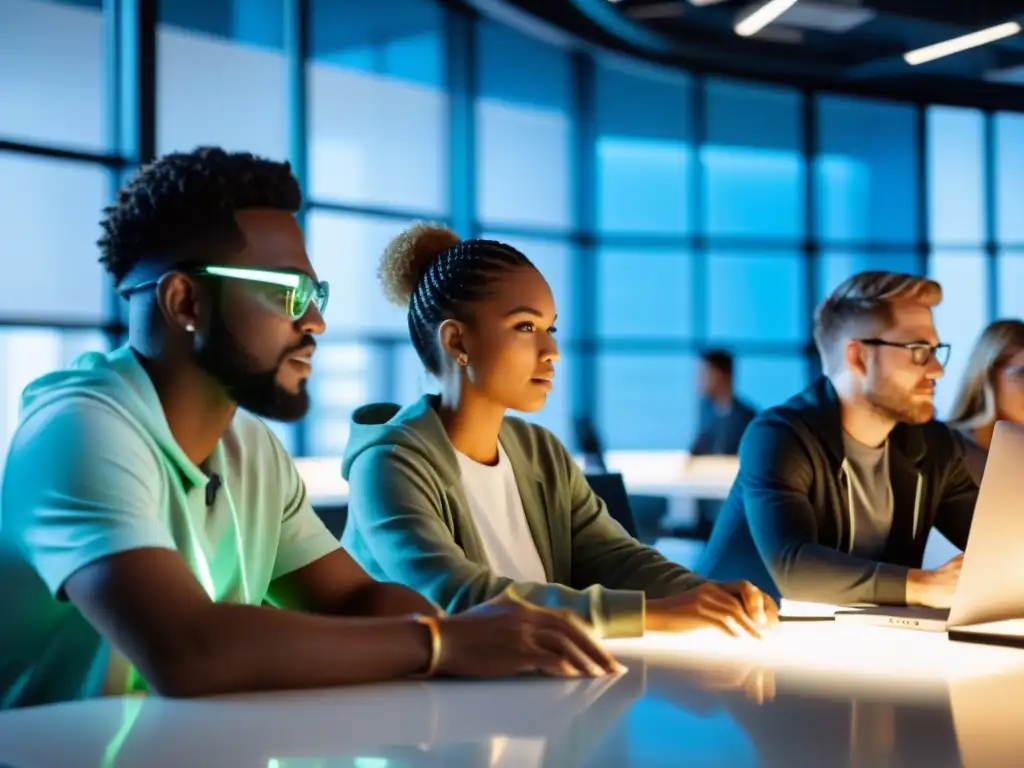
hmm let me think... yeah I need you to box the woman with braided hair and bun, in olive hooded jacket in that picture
[342,224,777,637]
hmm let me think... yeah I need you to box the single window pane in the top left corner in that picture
[0,0,108,151]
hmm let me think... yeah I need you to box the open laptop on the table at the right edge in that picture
[836,421,1024,642]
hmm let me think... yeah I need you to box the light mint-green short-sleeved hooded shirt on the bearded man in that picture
[0,348,339,709]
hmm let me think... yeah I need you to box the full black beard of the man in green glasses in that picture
[196,306,315,422]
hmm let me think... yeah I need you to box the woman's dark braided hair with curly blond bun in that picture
[378,223,534,376]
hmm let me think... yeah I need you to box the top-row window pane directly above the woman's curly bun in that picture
[306,0,449,215]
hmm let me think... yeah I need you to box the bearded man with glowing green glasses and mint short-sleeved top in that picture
[0,148,615,708]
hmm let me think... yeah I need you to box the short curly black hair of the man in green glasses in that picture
[98,146,302,285]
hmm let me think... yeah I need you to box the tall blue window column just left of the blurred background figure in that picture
[592,56,697,449]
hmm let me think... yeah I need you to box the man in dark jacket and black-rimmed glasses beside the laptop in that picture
[697,271,978,607]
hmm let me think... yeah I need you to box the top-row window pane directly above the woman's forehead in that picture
[476,22,572,228]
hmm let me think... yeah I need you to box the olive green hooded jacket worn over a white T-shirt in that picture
[342,395,703,637]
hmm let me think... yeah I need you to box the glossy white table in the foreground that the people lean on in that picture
[0,622,1024,768]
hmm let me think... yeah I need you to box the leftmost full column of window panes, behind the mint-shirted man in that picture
[0,0,121,477]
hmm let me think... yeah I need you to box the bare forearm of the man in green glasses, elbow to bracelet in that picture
[147,603,430,696]
